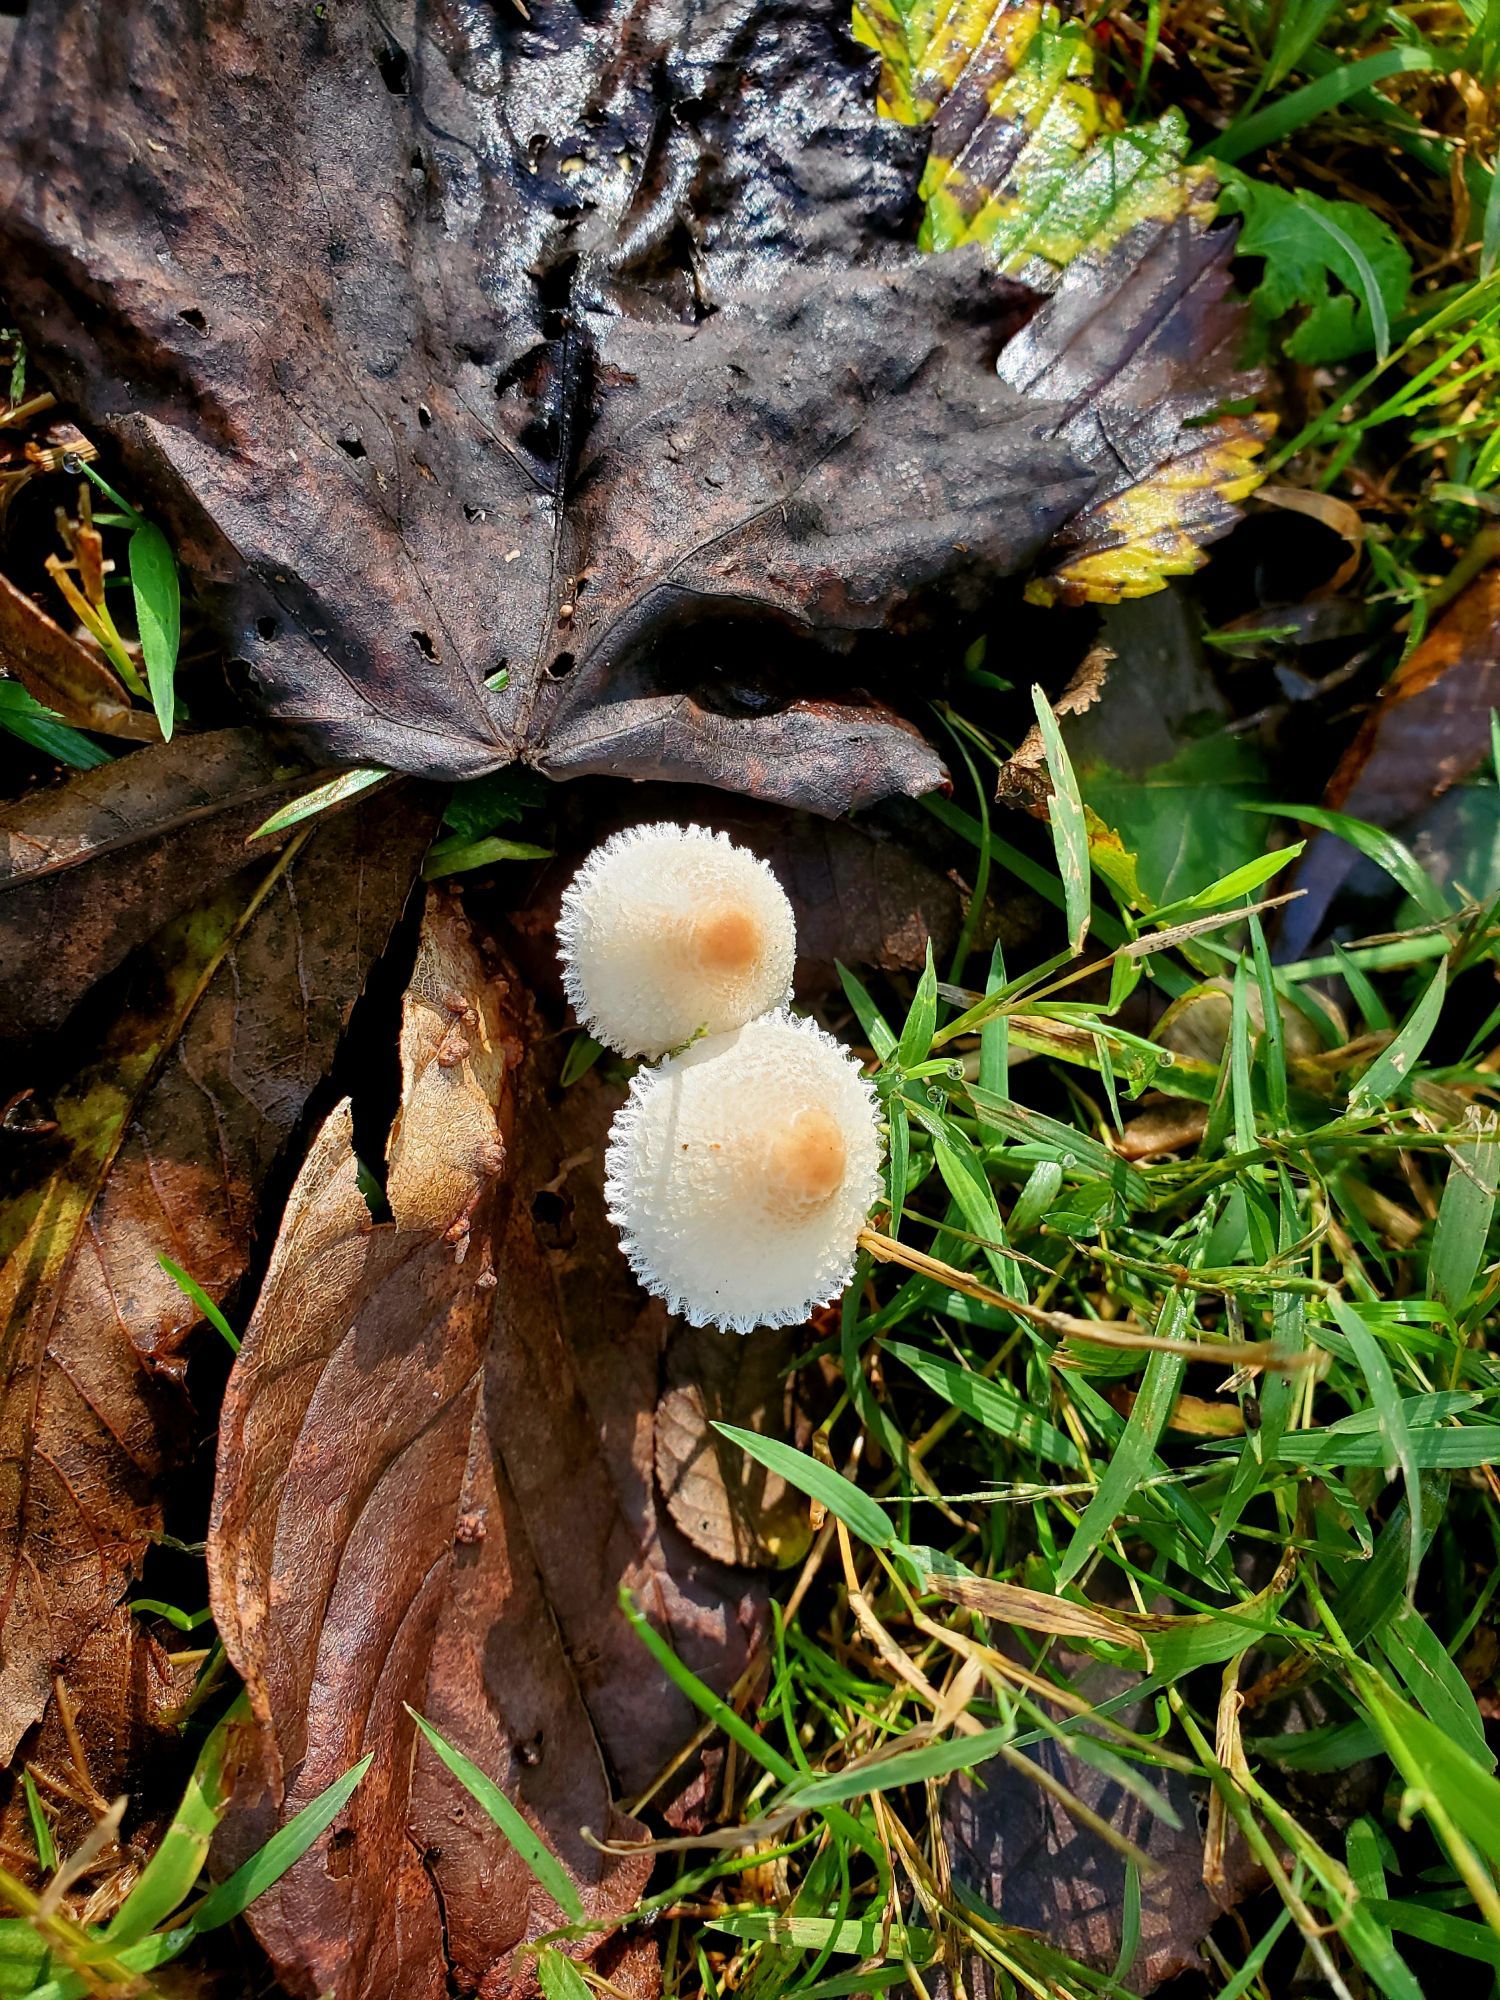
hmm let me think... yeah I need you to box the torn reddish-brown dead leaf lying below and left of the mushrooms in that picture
[210,896,758,2000]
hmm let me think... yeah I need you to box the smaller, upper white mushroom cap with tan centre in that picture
[558,822,796,1056]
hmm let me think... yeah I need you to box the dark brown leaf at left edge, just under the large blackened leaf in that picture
[0,730,304,1038]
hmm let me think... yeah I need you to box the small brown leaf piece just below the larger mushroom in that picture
[656,1324,812,1570]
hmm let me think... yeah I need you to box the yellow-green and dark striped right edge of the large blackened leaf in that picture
[856,0,1272,604]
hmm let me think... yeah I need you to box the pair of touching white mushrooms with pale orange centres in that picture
[558,824,880,1334]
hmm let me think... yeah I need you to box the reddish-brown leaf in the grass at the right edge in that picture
[1280,568,1500,958]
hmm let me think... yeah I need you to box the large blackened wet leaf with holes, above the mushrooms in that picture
[0,0,1254,814]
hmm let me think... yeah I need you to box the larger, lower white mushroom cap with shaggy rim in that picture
[606,1014,880,1334]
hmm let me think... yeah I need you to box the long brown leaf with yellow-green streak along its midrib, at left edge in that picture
[0,802,430,1760]
